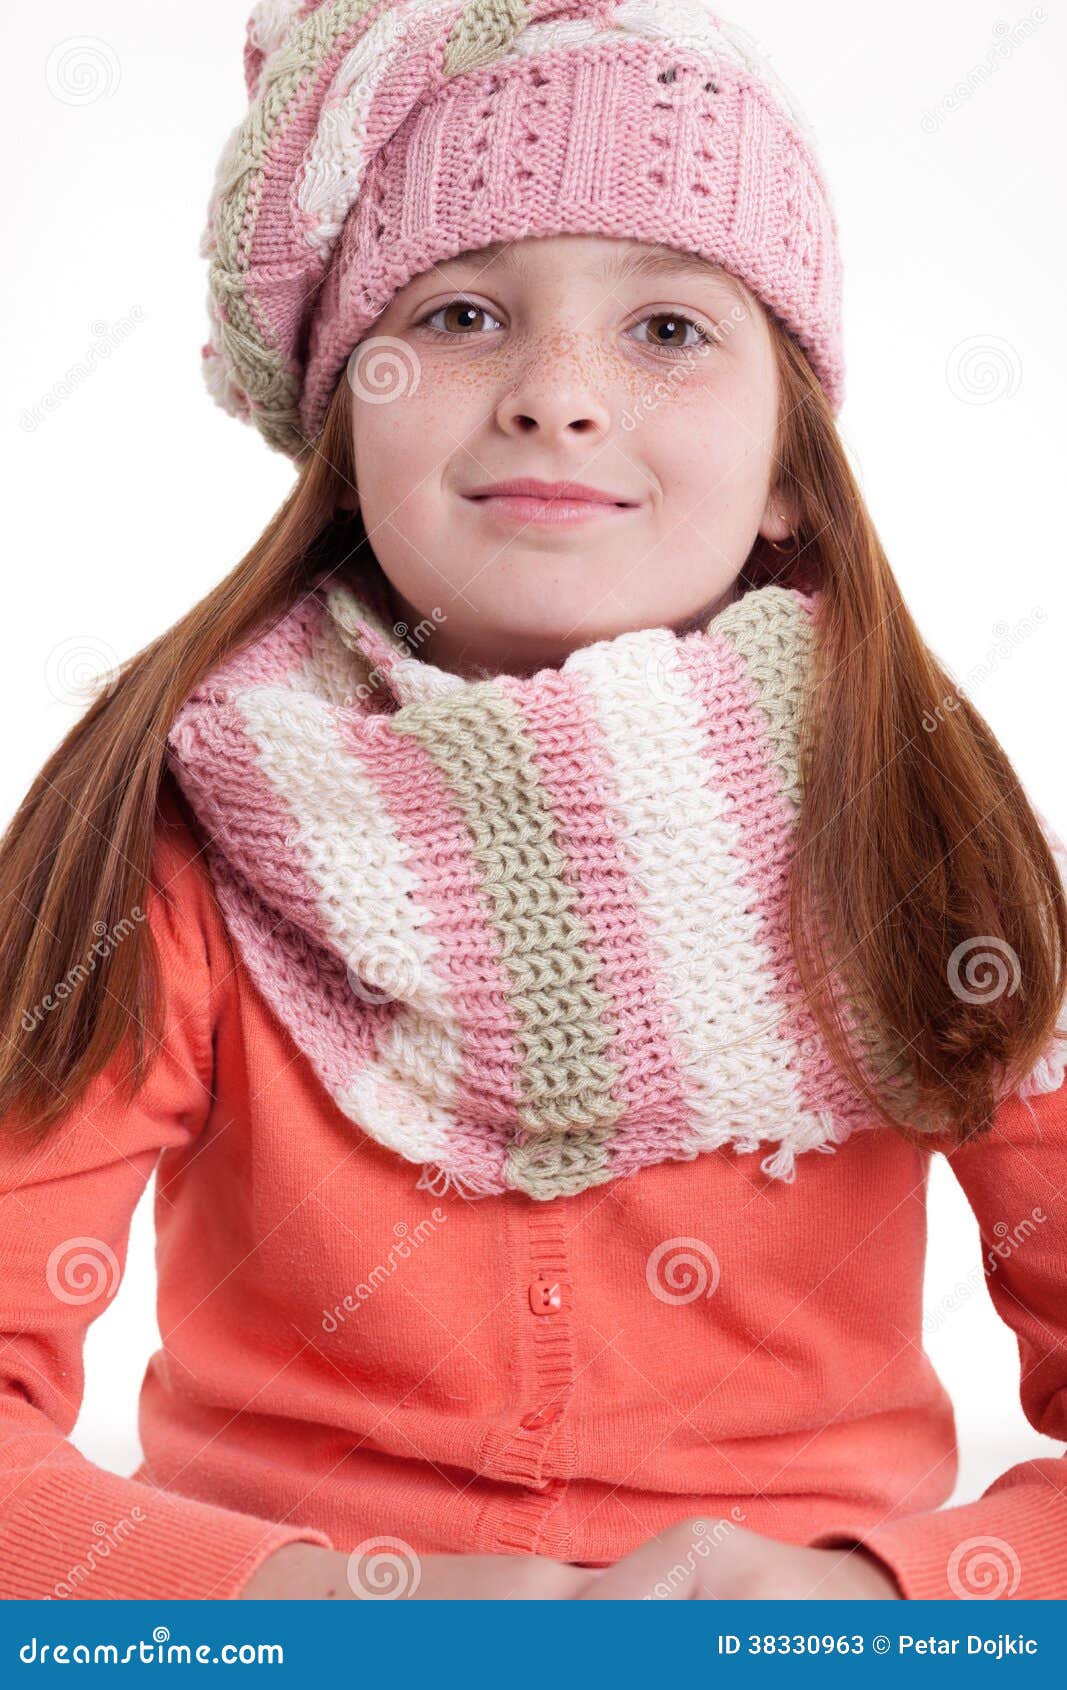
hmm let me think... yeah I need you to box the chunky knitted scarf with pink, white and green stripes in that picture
[167,573,1062,1200]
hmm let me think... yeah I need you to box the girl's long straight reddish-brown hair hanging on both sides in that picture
[0,318,1067,1142]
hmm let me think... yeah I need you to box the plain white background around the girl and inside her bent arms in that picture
[0,0,1067,1521]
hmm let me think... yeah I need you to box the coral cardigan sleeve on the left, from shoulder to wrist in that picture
[0,780,333,1600]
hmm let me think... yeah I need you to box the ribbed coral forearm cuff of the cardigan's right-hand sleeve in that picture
[807,1480,1067,1602]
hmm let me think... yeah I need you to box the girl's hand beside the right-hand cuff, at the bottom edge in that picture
[578,1518,903,1602]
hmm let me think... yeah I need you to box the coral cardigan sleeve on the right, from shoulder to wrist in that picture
[808,1082,1067,1602]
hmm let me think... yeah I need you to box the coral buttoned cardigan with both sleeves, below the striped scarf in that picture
[0,784,1067,1599]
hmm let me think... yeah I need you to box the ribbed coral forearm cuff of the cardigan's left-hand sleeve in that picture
[0,1462,333,1600]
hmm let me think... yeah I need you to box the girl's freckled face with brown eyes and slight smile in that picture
[348,235,791,673]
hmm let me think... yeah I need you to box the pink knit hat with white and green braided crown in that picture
[201,0,844,460]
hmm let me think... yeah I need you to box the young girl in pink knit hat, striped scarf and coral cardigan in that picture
[0,0,1067,1599]
